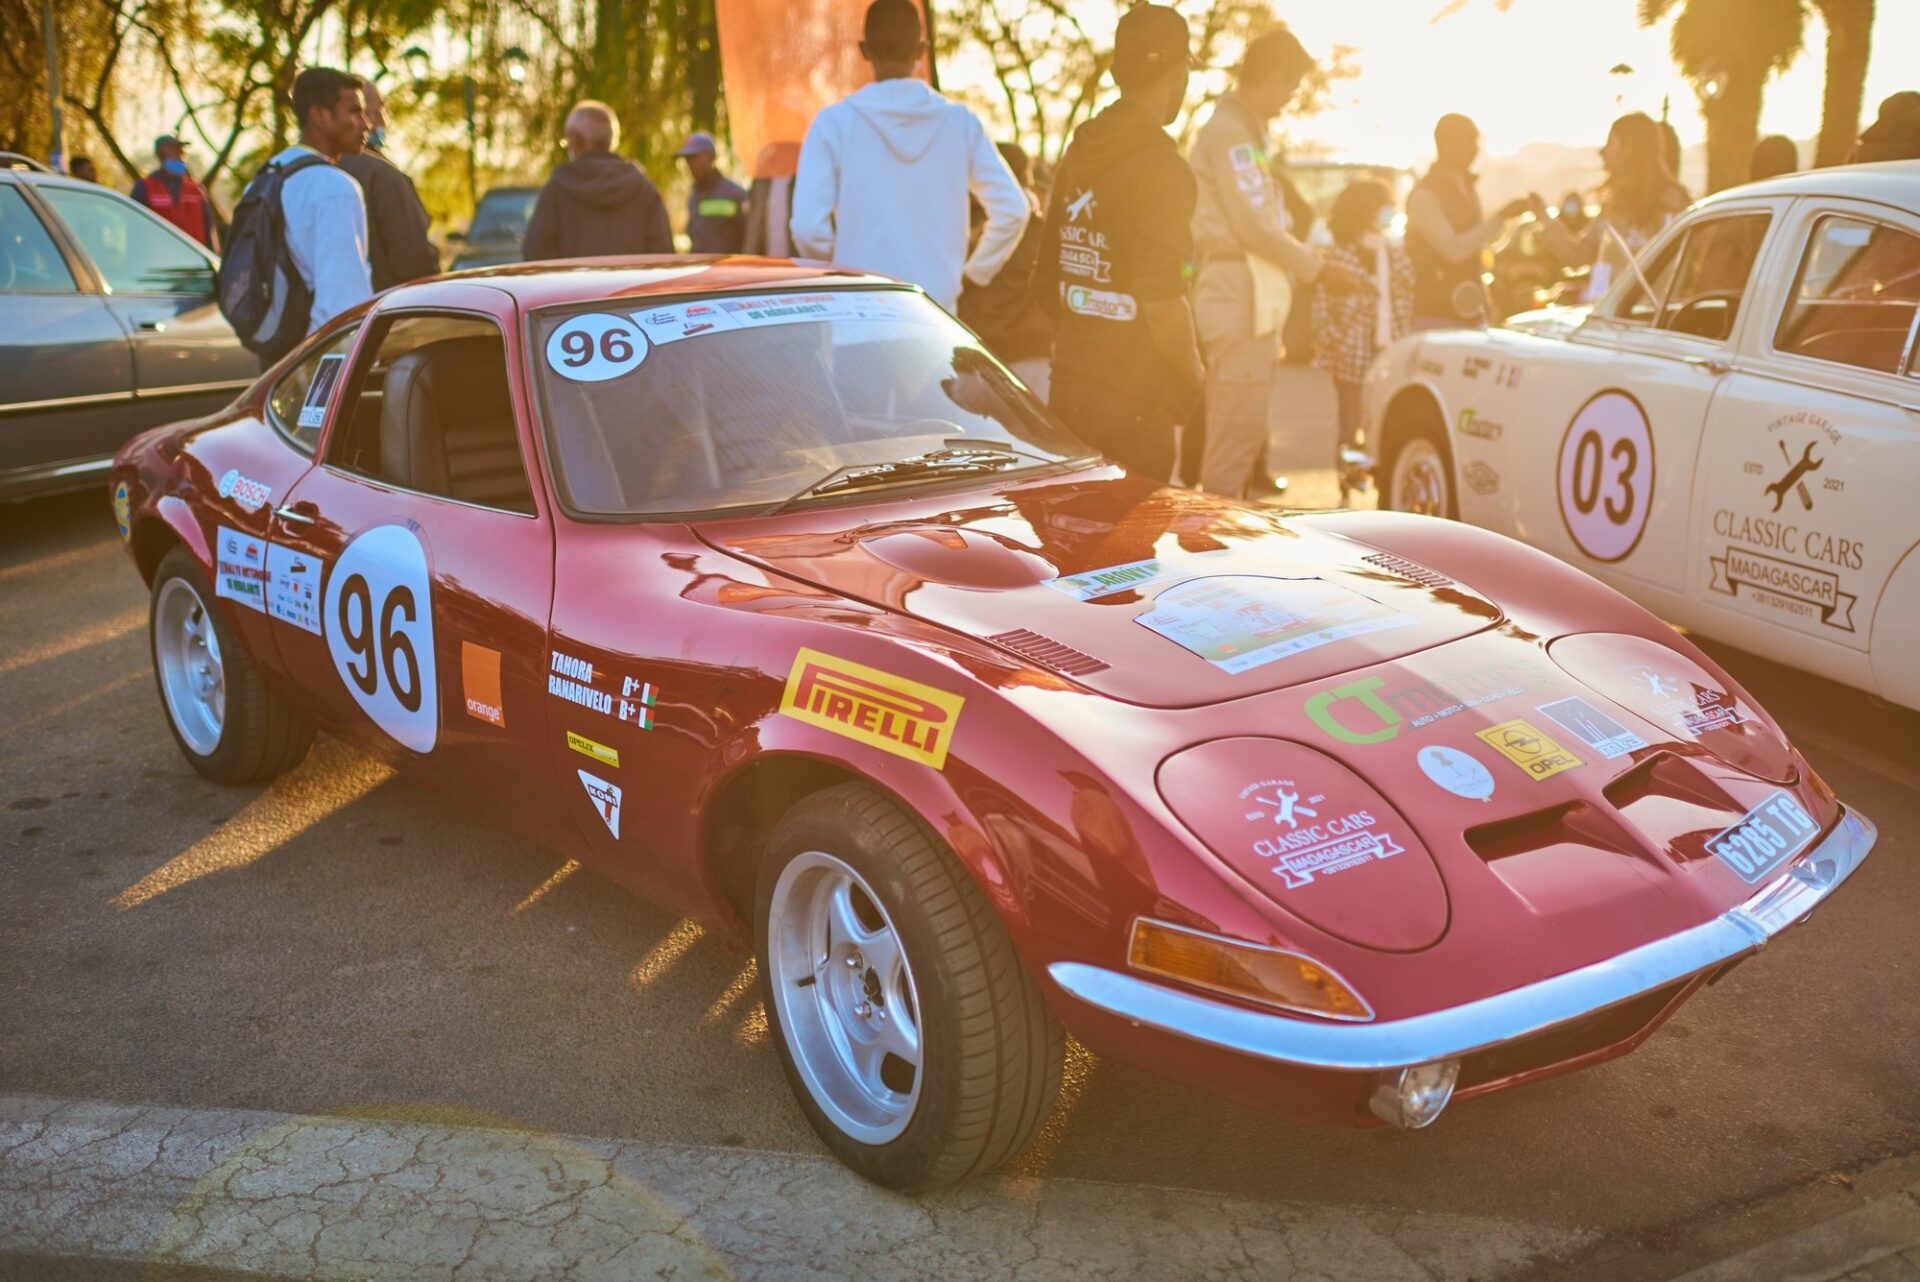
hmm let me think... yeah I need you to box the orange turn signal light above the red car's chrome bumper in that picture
[1127,917,1373,1021]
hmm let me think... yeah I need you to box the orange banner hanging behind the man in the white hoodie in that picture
[714,0,925,178]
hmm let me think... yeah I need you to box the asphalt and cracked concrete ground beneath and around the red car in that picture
[0,479,1920,1282]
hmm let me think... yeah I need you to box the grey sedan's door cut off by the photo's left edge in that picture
[0,180,132,485]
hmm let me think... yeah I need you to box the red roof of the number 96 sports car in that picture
[414,253,899,309]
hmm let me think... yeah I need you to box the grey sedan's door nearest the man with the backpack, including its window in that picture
[40,184,259,422]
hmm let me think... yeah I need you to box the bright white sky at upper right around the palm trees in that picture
[1275,0,1920,165]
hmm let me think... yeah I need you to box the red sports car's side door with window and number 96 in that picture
[269,297,564,829]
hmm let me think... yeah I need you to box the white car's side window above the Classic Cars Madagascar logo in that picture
[1774,213,1920,374]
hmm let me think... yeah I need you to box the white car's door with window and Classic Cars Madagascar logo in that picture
[1688,198,1920,699]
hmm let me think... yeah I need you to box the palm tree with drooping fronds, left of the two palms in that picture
[1640,0,1807,192]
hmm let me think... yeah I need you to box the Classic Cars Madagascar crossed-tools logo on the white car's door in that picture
[1707,411,1866,631]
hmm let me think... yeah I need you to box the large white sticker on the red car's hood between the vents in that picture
[1135,576,1415,672]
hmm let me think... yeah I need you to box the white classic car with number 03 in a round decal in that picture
[1365,161,1920,708]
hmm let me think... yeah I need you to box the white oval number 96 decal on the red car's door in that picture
[323,526,440,752]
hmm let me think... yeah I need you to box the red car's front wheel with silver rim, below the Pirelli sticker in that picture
[755,783,1064,1190]
